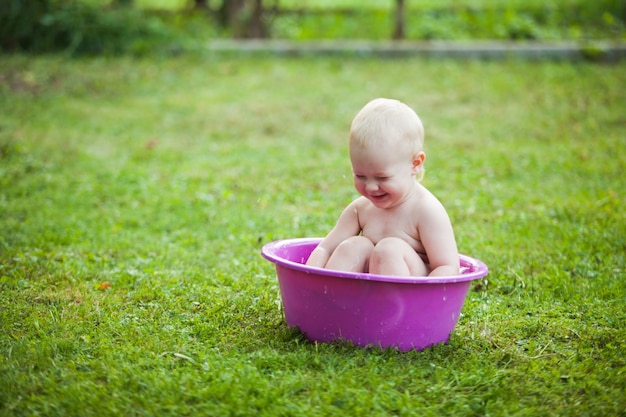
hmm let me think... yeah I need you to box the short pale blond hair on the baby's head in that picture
[350,98,424,179]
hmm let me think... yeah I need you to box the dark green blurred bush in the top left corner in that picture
[0,0,183,54]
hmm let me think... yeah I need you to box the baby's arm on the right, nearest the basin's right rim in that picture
[419,197,460,277]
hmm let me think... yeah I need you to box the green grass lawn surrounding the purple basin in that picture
[0,55,626,416]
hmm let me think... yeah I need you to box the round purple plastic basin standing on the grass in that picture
[261,238,488,351]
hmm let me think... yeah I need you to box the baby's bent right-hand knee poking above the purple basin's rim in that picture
[370,237,429,277]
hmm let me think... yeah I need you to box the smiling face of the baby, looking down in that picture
[350,145,416,208]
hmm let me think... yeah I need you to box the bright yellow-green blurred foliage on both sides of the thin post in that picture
[272,0,626,40]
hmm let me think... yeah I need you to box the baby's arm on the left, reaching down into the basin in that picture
[306,201,361,268]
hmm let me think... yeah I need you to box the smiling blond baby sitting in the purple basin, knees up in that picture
[307,98,460,276]
